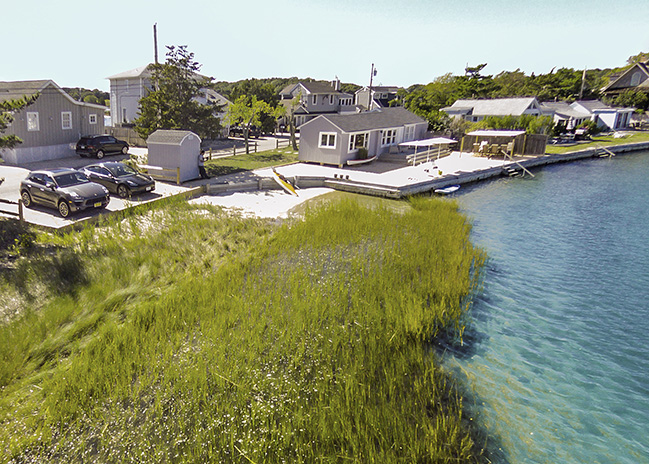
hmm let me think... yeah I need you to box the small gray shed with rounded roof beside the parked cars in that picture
[146,129,201,182]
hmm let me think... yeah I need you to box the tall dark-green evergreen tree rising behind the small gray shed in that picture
[135,45,221,139]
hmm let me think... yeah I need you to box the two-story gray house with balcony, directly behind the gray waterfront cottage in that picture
[279,79,357,126]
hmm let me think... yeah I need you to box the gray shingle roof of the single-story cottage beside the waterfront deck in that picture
[312,107,426,132]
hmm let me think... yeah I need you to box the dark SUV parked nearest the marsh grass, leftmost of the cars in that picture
[20,168,110,217]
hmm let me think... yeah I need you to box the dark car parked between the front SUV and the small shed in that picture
[81,161,155,198]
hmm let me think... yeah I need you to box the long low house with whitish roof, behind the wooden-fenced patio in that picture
[441,97,543,122]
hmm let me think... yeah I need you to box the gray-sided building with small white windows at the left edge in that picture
[0,80,108,165]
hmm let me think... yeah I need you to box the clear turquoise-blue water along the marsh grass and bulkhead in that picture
[449,152,649,464]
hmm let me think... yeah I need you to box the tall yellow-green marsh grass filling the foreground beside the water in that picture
[0,195,485,463]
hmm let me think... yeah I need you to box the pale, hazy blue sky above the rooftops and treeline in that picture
[0,0,649,91]
